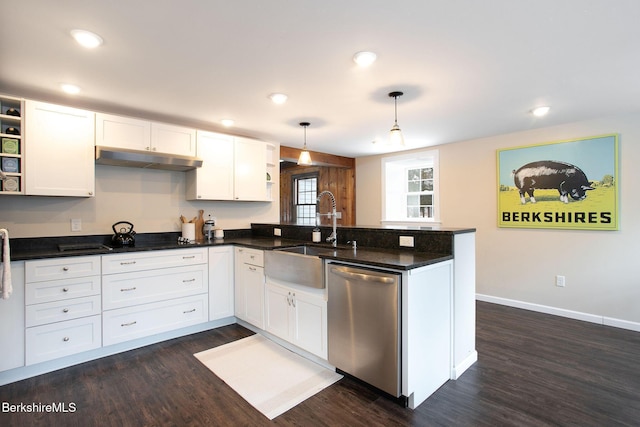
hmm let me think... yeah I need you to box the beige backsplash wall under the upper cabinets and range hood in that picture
[0,165,280,238]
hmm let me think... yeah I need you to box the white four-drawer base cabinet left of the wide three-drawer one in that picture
[25,255,102,365]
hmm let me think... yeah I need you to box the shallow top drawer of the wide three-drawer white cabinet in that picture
[102,248,207,274]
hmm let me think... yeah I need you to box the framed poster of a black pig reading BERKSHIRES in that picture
[497,134,619,230]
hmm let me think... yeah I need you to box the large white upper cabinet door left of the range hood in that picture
[25,100,95,197]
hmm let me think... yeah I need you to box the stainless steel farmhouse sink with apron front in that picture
[264,245,327,289]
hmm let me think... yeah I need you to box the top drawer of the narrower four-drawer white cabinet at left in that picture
[24,256,100,283]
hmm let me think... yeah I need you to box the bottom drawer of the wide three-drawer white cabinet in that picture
[102,294,209,346]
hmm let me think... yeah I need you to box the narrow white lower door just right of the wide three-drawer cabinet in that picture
[209,246,234,320]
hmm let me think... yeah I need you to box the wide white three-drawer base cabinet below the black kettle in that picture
[102,248,209,346]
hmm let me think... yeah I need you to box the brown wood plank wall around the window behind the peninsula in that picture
[280,163,356,226]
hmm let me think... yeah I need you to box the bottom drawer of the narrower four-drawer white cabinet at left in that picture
[26,315,102,365]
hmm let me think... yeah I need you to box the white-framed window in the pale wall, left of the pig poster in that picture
[382,150,439,223]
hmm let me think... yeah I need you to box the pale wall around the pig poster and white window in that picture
[356,114,640,329]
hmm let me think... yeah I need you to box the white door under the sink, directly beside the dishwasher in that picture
[293,291,328,359]
